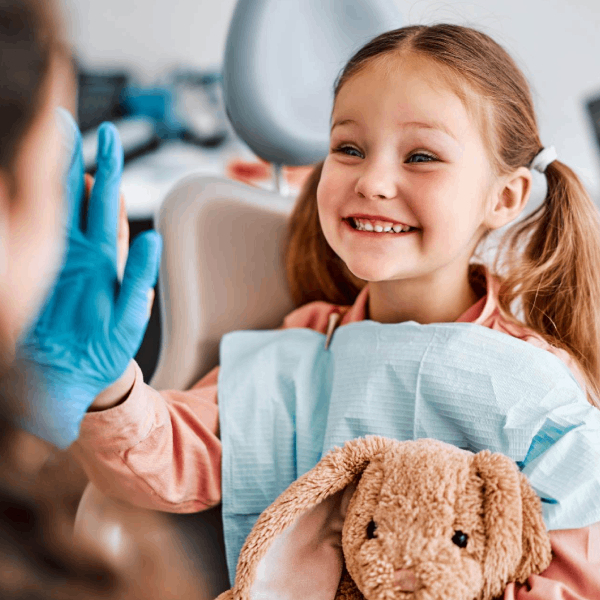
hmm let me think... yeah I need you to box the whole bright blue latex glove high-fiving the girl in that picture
[19,111,162,448]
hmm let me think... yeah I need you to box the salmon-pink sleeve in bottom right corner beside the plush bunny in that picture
[503,523,600,600]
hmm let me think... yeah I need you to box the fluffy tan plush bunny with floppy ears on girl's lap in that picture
[218,436,551,600]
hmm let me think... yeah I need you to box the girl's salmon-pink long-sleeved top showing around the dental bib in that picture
[71,270,600,600]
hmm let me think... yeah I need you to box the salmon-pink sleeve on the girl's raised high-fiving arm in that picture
[71,364,221,512]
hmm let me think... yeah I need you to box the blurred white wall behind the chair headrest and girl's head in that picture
[62,0,600,201]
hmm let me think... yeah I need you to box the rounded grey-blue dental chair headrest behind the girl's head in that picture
[223,0,400,165]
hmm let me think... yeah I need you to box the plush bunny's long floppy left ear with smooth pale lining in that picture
[233,436,391,600]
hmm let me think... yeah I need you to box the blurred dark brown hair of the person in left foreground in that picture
[0,0,123,600]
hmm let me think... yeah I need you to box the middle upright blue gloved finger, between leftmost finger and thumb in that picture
[86,123,123,269]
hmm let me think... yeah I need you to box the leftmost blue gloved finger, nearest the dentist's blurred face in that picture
[56,108,85,231]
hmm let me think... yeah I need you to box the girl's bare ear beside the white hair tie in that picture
[486,167,532,229]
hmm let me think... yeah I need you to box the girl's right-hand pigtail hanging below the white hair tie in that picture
[497,160,600,408]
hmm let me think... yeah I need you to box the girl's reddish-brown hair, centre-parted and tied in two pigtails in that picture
[287,24,600,407]
